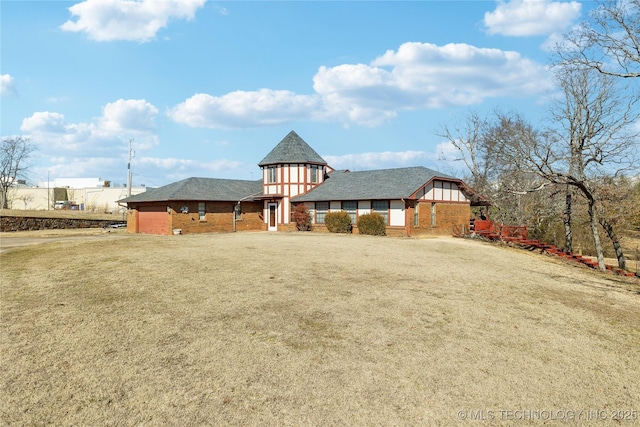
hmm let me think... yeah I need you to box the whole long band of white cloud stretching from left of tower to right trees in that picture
[168,43,552,128]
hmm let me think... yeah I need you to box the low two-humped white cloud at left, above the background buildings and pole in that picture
[20,99,158,155]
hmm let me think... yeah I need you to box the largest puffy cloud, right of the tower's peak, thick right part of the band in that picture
[314,42,550,125]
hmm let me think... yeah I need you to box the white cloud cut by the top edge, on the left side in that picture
[60,0,206,42]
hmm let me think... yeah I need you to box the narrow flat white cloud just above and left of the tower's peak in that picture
[168,89,318,128]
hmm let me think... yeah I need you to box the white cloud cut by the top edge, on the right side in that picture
[484,0,582,37]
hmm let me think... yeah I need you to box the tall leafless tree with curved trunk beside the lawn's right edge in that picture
[510,66,639,269]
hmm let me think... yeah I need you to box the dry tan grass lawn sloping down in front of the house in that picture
[0,233,640,426]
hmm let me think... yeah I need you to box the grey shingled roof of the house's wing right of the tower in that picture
[292,166,460,202]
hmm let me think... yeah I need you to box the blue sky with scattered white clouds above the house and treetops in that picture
[0,0,595,186]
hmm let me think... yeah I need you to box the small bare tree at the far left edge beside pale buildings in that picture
[0,136,33,209]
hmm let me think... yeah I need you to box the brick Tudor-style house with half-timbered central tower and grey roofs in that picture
[119,131,488,236]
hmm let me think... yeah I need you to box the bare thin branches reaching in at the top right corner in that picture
[556,0,640,78]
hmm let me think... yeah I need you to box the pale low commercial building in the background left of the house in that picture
[7,178,147,213]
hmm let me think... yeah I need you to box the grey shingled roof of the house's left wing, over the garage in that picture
[118,178,262,203]
